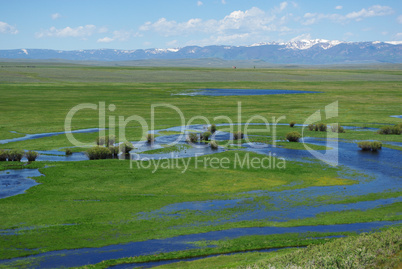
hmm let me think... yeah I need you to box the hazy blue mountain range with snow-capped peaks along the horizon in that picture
[0,39,402,64]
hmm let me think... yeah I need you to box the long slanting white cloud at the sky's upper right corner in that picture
[302,5,394,25]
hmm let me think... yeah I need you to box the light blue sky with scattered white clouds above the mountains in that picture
[0,0,402,50]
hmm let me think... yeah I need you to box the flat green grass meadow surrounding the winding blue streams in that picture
[0,63,402,268]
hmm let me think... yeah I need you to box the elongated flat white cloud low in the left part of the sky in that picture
[35,24,96,38]
